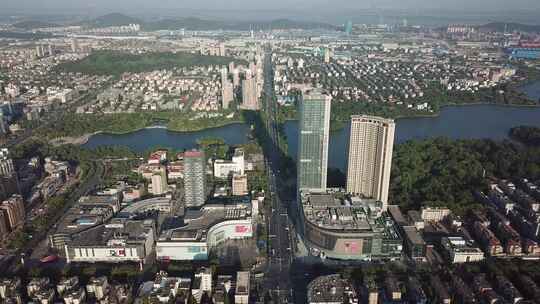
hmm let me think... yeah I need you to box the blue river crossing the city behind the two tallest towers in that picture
[84,105,540,170]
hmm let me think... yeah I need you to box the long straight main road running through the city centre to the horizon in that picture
[263,48,294,303]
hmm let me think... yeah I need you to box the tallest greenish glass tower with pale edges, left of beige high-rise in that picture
[298,90,332,191]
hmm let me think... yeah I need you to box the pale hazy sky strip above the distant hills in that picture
[0,0,540,13]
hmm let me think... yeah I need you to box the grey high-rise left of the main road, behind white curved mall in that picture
[184,150,206,207]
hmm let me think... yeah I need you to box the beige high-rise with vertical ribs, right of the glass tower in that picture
[347,115,395,210]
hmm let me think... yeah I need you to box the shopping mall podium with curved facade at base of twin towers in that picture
[301,193,402,260]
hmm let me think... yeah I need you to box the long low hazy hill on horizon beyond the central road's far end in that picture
[143,17,336,31]
